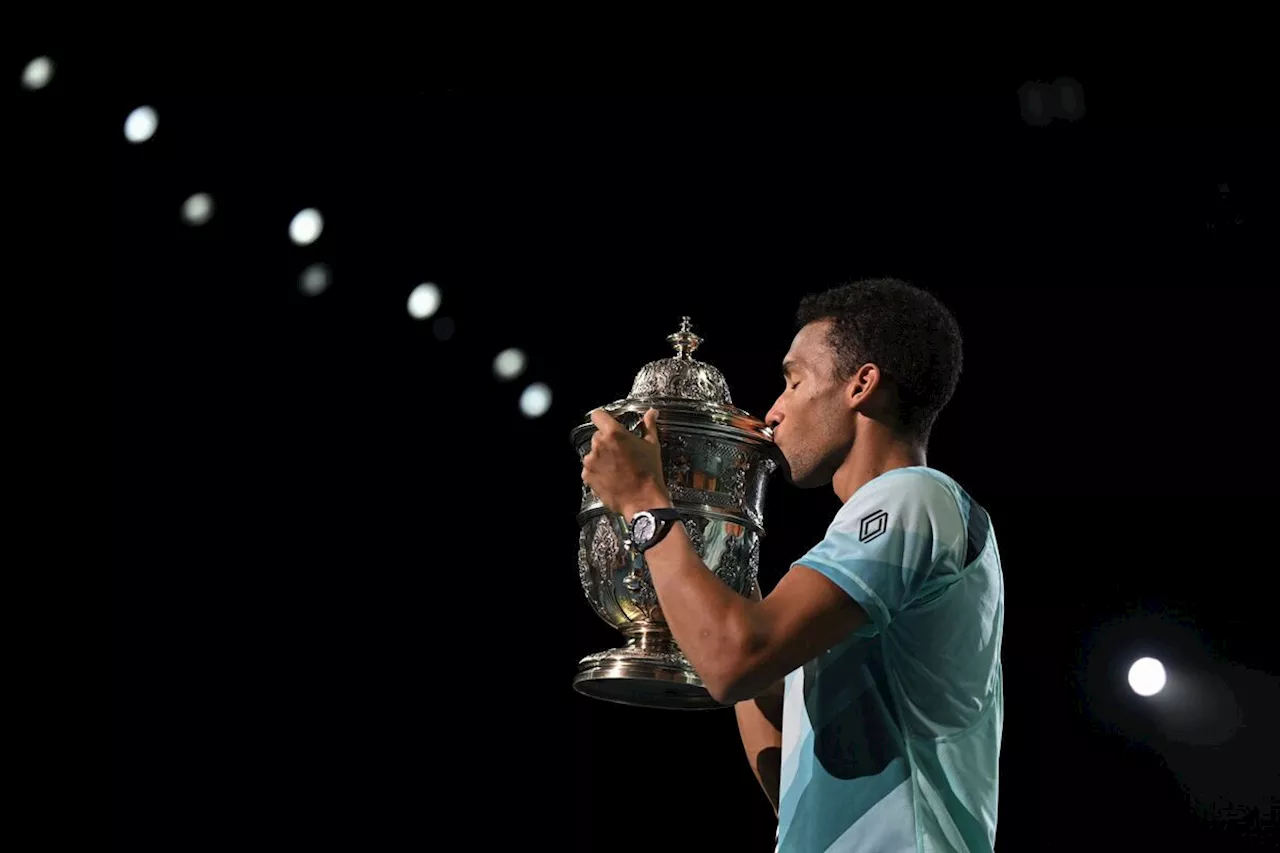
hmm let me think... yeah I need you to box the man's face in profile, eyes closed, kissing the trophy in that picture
[764,320,854,489]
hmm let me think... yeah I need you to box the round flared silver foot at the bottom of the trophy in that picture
[573,630,728,711]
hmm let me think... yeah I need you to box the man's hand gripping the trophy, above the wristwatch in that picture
[582,409,671,520]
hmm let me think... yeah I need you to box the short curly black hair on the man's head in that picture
[796,278,964,447]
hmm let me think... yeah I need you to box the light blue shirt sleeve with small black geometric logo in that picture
[795,469,965,633]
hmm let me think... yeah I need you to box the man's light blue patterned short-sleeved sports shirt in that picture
[777,466,1005,853]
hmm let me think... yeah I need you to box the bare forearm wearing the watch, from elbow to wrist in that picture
[627,491,756,701]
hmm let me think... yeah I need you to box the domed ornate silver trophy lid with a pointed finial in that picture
[584,316,773,444]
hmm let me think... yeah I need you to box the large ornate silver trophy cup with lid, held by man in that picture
[571,316,778,710]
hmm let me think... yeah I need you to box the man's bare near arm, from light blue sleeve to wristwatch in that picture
[621,481,868,704]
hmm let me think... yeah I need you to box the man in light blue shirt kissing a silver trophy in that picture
[582,279,1004,853]
